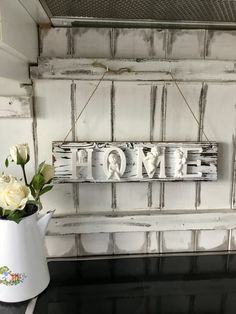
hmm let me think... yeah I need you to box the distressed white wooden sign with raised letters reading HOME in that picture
[53,142,218,183]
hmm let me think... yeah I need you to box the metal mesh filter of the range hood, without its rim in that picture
[43,0,236,22]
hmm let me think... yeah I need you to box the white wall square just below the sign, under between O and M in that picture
[116,182,148,211]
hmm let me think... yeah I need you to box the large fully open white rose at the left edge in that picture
[0,181,31,210]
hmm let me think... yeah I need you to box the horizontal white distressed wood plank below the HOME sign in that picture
[48,210,236,235]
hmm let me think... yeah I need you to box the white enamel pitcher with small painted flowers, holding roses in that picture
[0,211,54,302]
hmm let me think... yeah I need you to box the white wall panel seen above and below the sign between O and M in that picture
[114,82,151,210]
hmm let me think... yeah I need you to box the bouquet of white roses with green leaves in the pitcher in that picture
[0,144,54,223]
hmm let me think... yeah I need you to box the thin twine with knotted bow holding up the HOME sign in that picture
[61,62,211,145]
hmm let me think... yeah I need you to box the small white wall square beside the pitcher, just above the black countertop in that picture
[45,235,77,257]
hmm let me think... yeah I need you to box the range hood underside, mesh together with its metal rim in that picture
[40,0,236,29]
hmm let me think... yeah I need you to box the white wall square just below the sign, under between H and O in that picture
[78,183,112,213]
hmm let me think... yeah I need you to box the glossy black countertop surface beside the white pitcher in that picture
[35,254,236,314]
